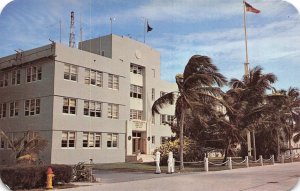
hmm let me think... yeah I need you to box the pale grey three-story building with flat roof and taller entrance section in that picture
[0,35,176,164]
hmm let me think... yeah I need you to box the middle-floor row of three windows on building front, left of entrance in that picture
[63,98,119,119]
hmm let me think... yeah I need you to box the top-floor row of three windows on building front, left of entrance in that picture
[64,64,119,90]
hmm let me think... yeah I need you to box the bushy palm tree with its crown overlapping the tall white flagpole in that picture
[229,66,277,159]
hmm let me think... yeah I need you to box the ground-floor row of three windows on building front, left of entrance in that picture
[61,131,119,148]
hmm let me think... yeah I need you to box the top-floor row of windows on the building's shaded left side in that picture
[0,66,42,87]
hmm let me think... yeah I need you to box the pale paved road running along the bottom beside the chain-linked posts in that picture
[57,162,300,191]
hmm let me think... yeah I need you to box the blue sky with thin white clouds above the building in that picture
[0,0,300,89]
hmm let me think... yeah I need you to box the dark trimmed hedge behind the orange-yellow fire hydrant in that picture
[0,165,72,189]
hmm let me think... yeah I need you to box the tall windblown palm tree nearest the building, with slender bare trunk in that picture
[152,55,226,170]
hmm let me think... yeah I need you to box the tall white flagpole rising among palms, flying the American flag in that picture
[243,0,252,160]
